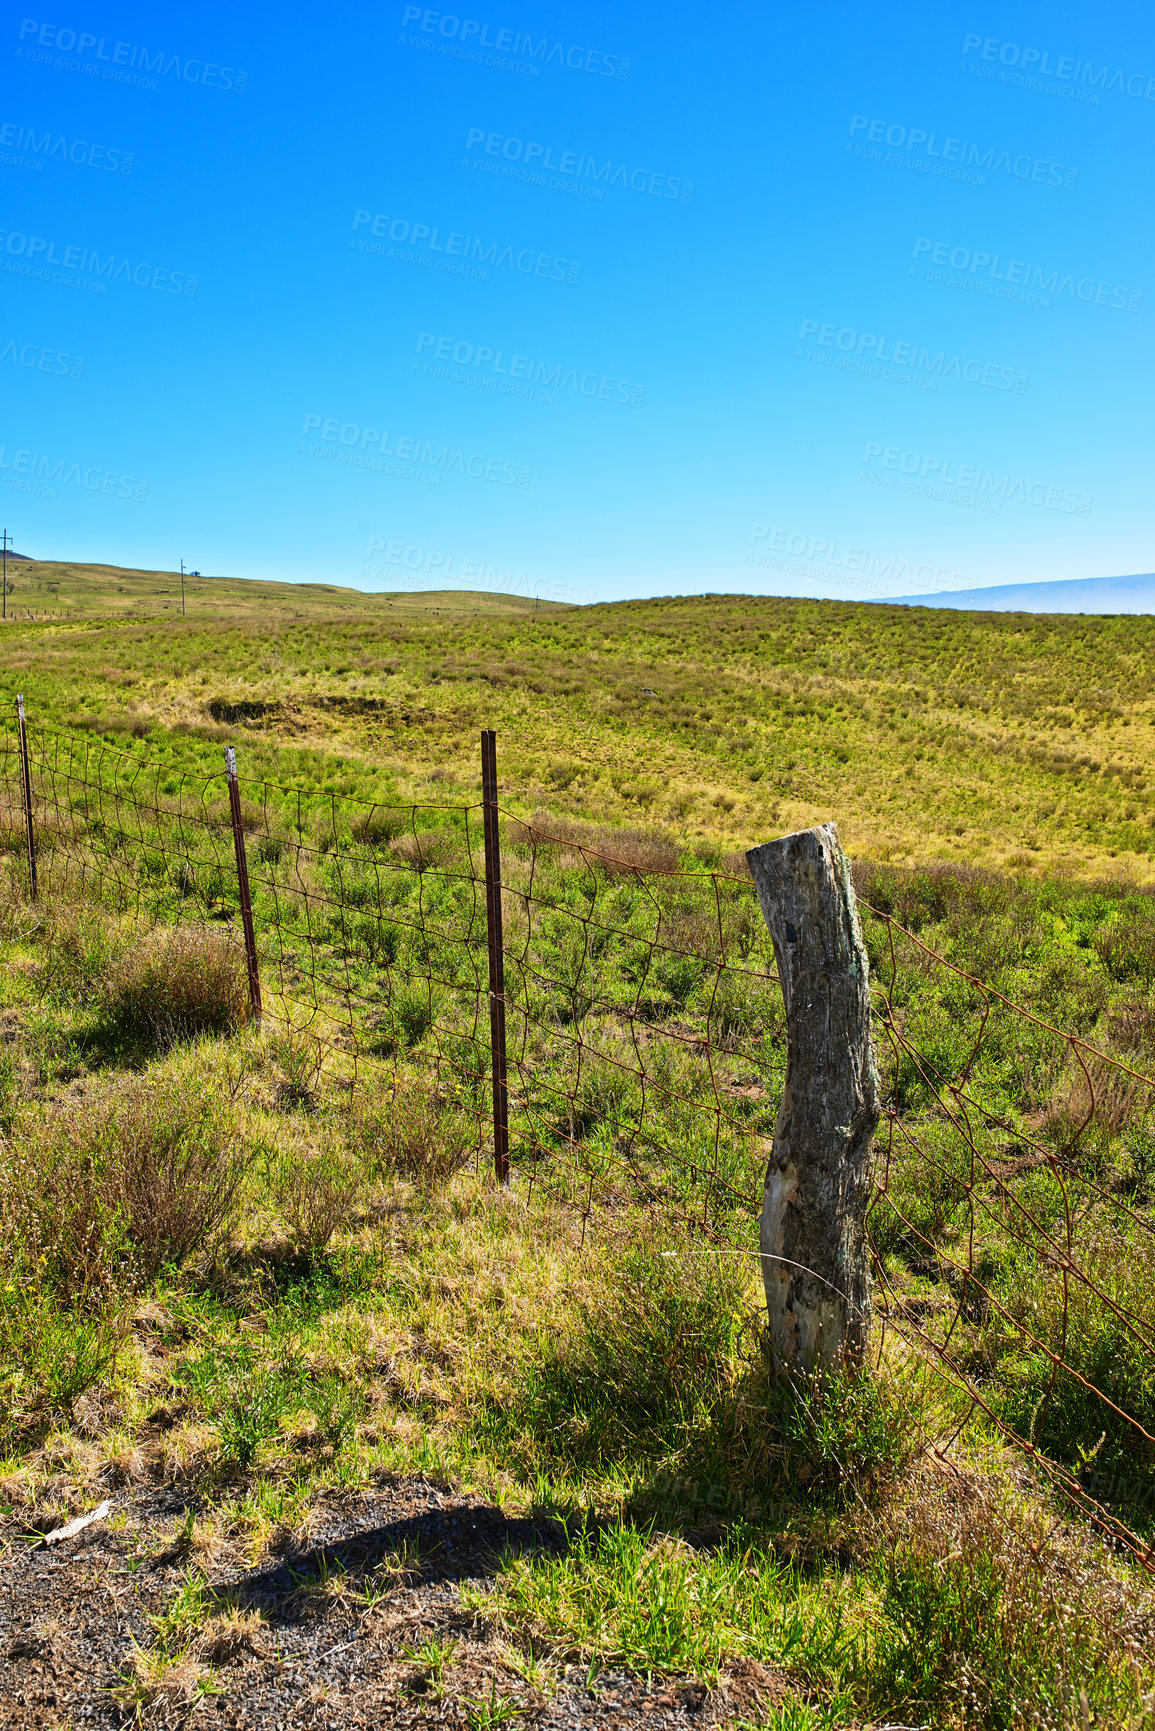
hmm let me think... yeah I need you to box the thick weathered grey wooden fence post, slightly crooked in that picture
[746,824,880,1374]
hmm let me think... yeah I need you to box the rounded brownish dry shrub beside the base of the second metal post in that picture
[102,926,249,1046]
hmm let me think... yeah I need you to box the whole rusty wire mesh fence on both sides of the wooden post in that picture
[0,702,1155,1568]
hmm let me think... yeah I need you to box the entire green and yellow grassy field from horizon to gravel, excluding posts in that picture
[0,566,1155,1731]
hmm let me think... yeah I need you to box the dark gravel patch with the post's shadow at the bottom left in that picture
[0,1478,788,1731]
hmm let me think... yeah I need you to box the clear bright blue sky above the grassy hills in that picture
[0,0,1155,599]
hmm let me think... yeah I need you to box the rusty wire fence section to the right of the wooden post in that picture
[864,909,1155,1568]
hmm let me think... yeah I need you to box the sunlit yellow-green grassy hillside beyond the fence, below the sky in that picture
[0,566,1155,883]
